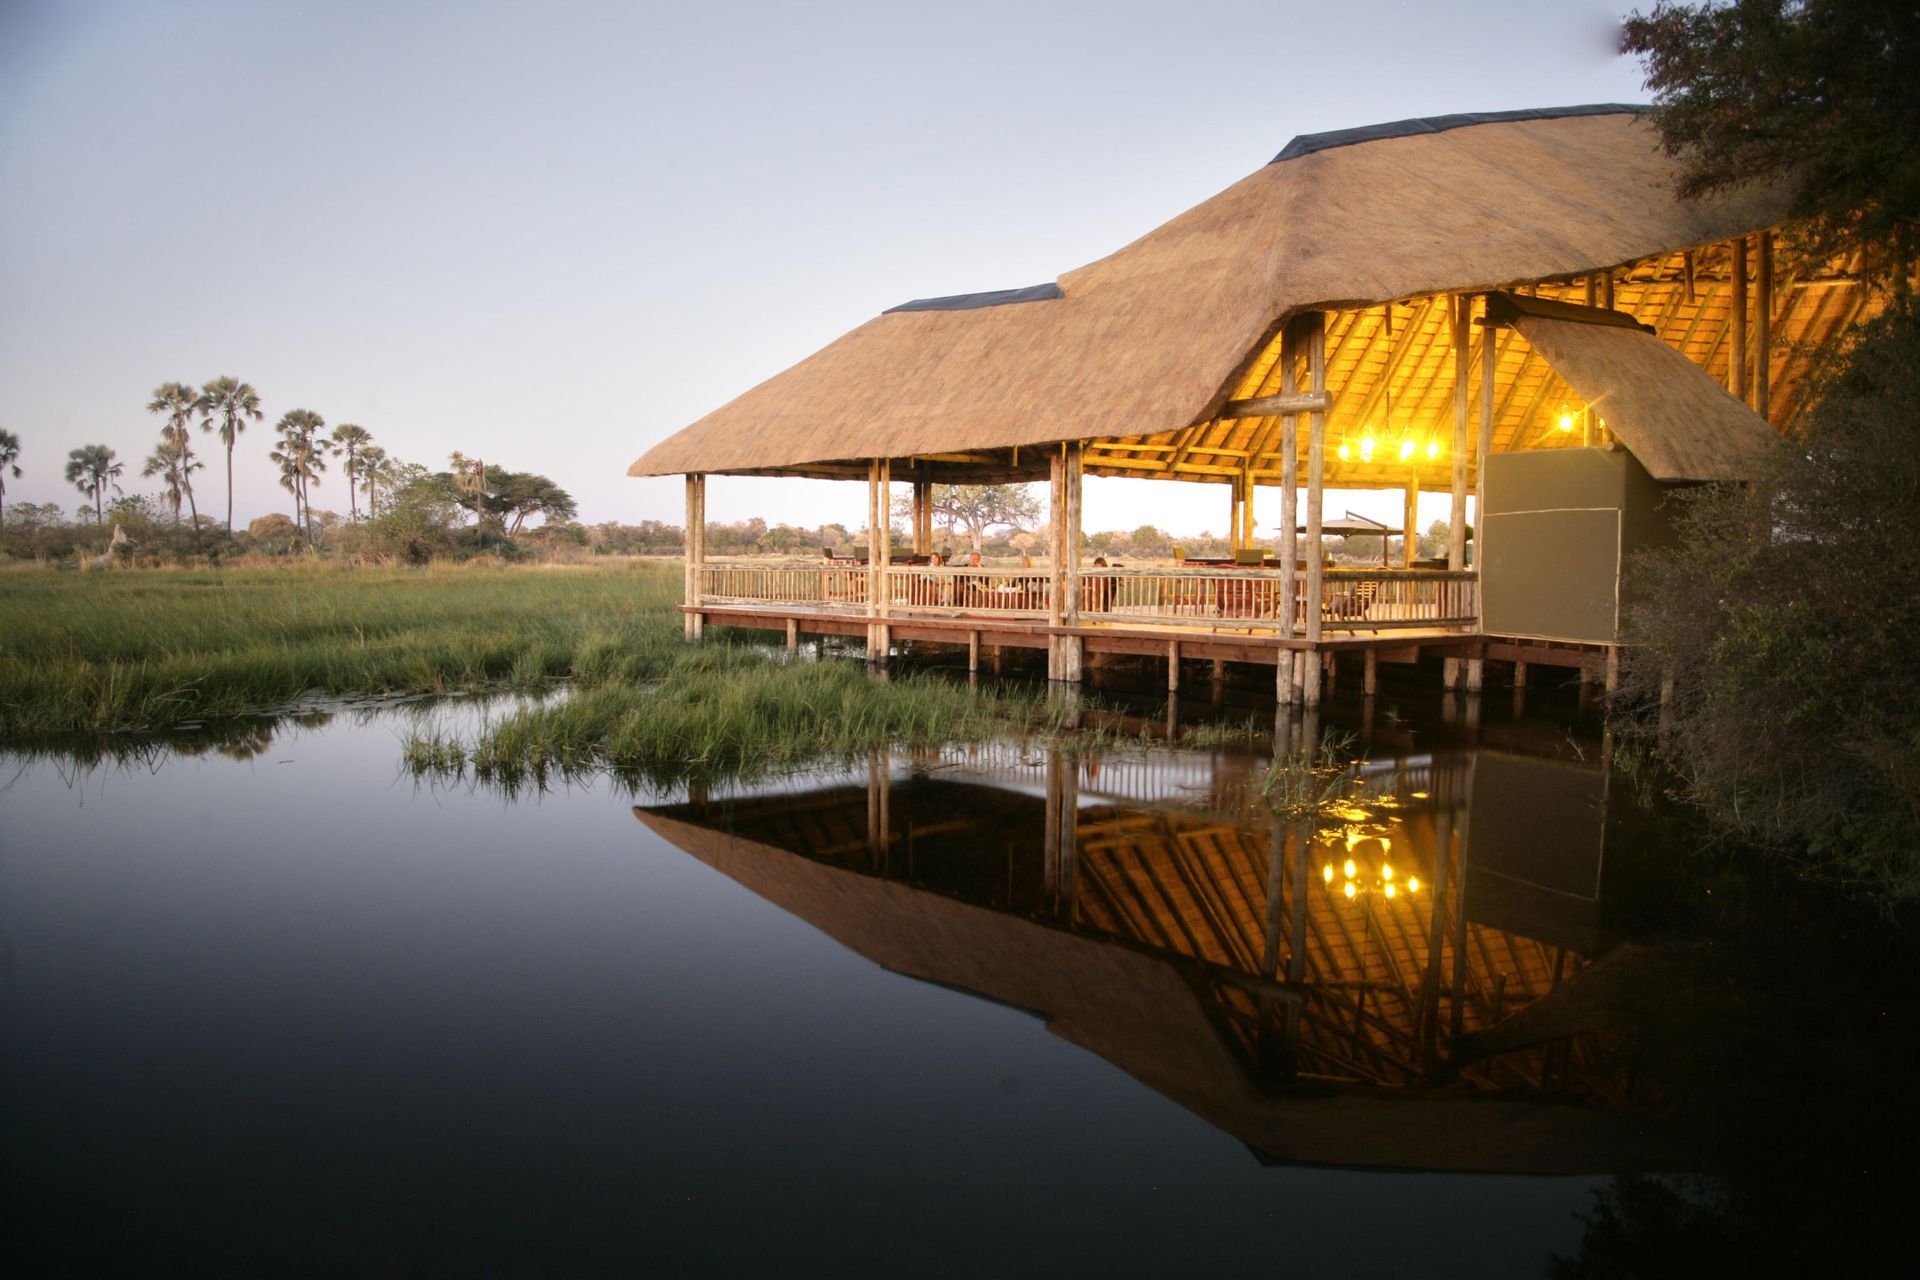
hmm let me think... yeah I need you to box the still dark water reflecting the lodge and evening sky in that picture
[0,687,1912,1276]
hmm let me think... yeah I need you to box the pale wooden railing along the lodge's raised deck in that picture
[697,560,1480,633]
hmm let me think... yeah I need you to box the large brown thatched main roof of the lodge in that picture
[630,107,1784,482]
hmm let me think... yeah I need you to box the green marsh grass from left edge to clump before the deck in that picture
[0,562,1082,781]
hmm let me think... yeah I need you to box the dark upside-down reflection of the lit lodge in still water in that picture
[636,722,1684,1173]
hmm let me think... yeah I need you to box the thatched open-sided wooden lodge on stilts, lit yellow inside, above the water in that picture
[630,106,1878,702]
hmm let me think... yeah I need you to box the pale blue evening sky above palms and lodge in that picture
[0,0,1645,533]
